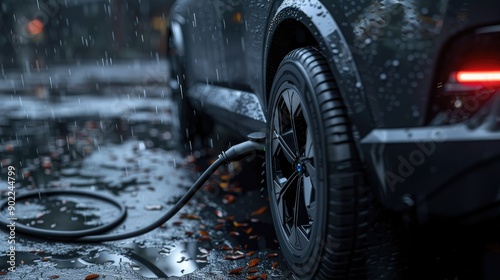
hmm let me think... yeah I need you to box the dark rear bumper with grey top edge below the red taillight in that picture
[360,93,500,221]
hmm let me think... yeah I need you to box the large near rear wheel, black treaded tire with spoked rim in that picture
[266,48,402,279]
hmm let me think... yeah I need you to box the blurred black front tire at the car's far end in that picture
[167,32,213,154]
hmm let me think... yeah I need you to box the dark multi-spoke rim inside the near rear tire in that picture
[271,89,317,252]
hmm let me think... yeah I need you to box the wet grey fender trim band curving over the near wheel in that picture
[263,0,373,140]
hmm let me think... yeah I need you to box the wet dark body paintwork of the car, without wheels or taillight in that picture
[171,0,500,221]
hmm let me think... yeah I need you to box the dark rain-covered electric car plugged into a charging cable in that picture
[168,0,500,279]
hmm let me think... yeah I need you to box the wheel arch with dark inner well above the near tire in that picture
[263,0,374,140]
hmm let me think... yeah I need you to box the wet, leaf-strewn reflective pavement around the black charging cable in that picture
[0,87,290,279]
